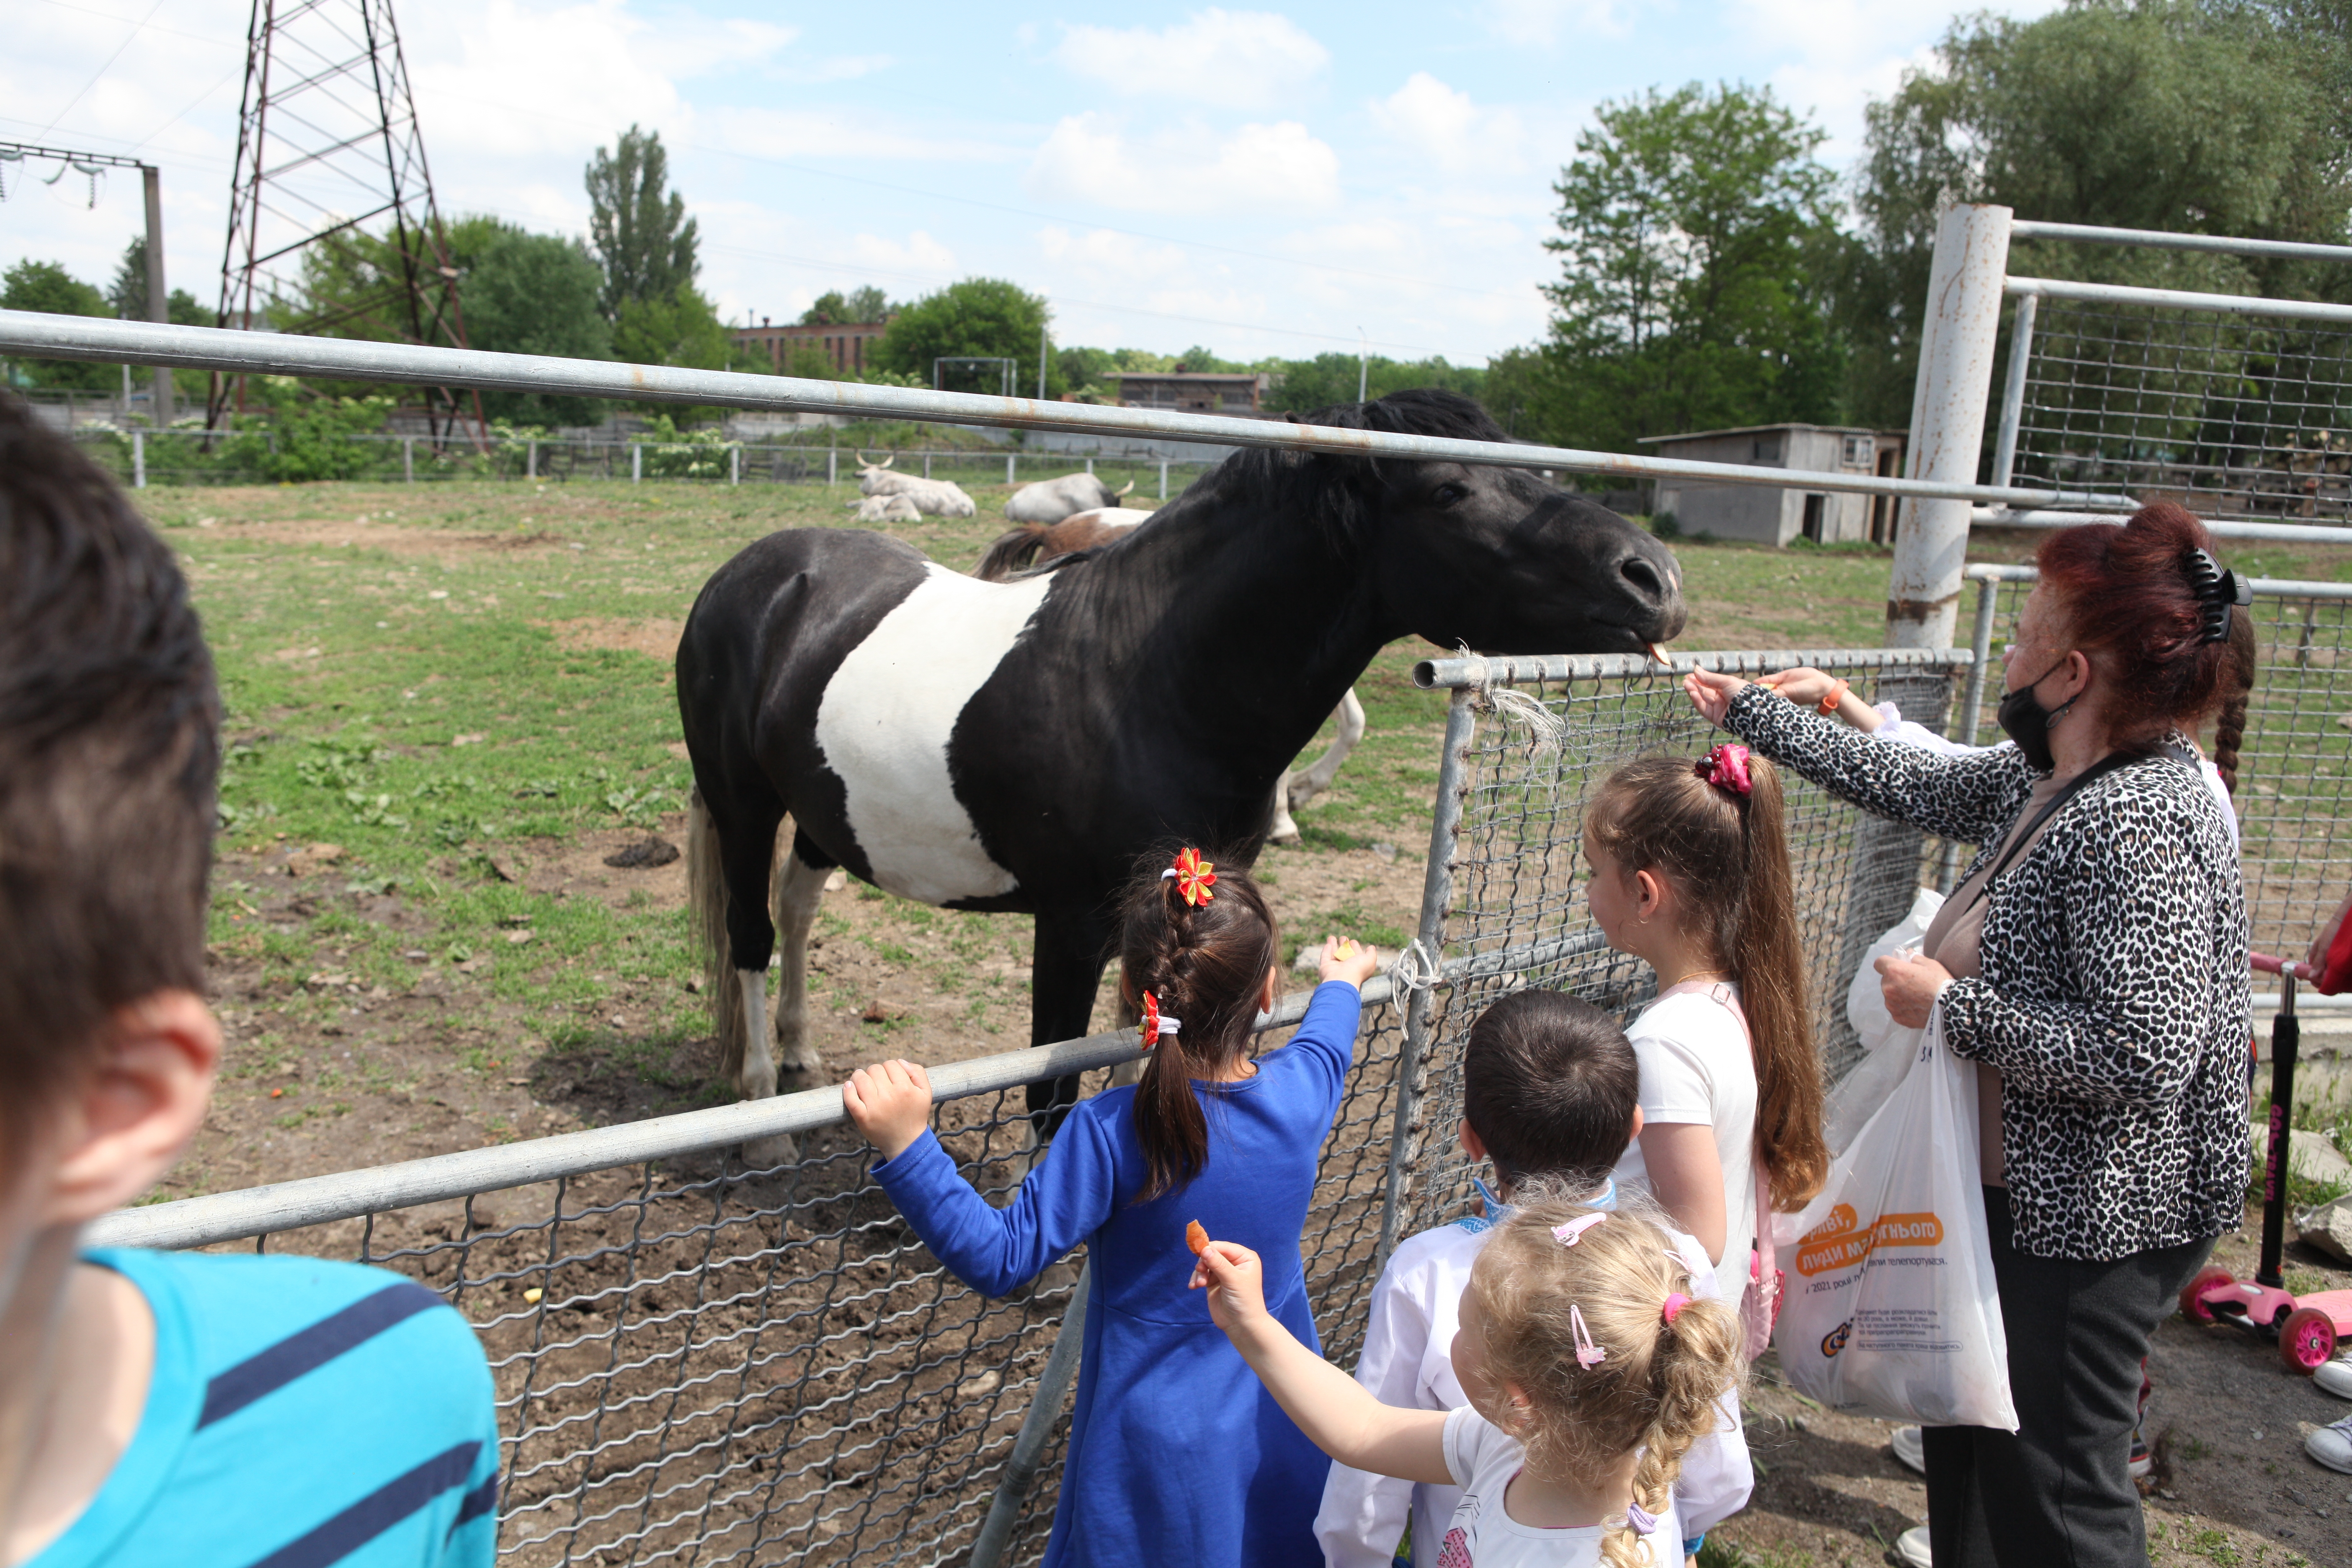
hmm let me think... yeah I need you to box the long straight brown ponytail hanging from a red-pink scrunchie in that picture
[1724,757,1830,1230]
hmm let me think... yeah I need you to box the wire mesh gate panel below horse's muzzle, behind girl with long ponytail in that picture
[1397,653,1955,1234]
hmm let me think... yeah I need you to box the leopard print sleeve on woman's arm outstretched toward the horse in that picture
[1724,682,2039,844]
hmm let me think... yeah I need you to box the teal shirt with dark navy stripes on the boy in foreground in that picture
[26,1251,499,1568]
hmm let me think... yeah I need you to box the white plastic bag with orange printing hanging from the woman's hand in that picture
[1773,1013,2018,1431]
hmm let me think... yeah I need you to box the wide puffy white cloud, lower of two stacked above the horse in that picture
[1028,113,1338,211]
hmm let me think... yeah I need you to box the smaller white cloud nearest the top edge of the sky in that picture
[1054,7,1331,111]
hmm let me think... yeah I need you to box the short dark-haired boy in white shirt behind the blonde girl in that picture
[1315,990,1755,1568]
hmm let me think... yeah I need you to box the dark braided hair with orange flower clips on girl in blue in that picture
[1119,851,1277,1204]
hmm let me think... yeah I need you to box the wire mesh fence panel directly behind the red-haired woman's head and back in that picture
[1975,580,2352,957]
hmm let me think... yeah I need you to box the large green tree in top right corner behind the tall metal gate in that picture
[1837,0,2352,423]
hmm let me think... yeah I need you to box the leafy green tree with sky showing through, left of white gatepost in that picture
[1517,85,1837,449]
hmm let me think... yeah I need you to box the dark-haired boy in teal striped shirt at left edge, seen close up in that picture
[0,397,499,1568]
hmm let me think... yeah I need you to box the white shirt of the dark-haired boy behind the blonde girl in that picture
[1315,1197,1755,1568]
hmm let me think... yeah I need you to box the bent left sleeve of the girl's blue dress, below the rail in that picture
[873,1098,1117,1295]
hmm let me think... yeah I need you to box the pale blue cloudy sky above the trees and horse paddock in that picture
[0,0,2051,364]
